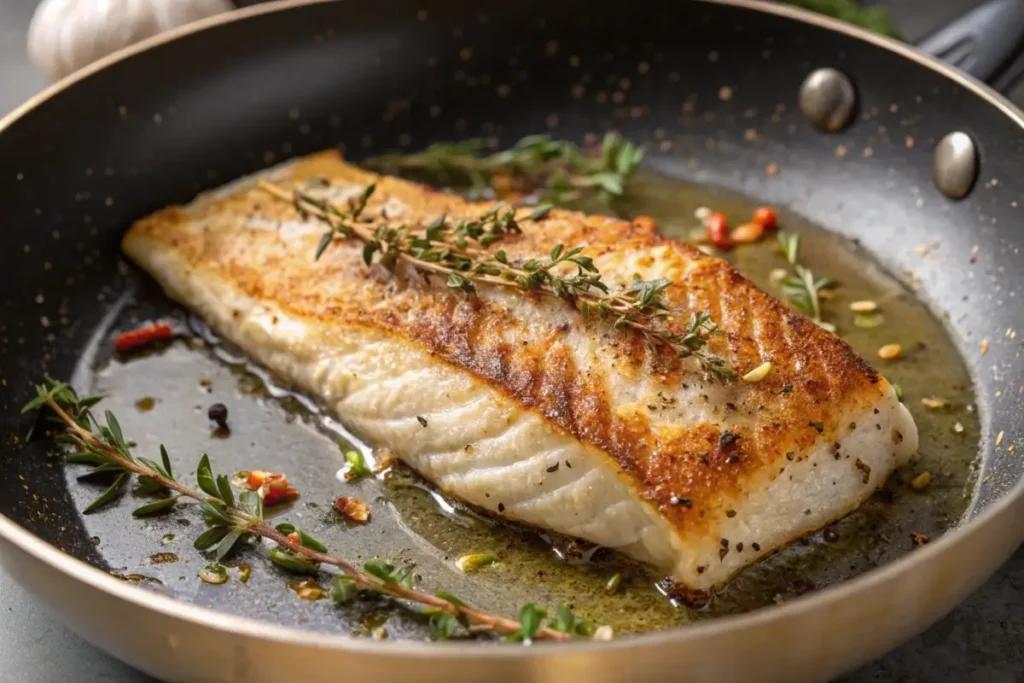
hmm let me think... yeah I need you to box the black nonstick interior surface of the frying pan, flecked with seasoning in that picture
[0,2,1024,647]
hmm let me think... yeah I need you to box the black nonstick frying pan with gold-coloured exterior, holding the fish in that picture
[0,0,1024,683]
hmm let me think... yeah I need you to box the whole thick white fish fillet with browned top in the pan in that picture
[123,153,918,594]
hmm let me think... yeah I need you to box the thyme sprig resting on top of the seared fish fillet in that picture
[259,180,734,380]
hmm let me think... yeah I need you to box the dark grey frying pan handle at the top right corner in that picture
[918,0,1024,92]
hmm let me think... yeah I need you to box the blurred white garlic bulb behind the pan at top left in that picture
[29,0,233,80]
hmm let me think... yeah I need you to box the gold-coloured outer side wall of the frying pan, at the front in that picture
[0,491,1024,683]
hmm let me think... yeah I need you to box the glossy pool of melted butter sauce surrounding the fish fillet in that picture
[69,169,979,637]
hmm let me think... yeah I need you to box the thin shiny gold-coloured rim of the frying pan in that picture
[0,0,1024,660]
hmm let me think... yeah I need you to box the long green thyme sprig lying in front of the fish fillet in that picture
[23,378,593,641]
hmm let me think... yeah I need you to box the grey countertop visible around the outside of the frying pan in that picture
[0,0,1024,683]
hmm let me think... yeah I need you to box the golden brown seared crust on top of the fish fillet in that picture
[126,153,890,531]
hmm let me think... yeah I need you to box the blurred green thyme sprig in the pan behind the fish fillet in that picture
[361,132,643,206]
